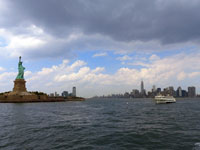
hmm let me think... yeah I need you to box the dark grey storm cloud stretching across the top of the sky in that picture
[0,0,200,44]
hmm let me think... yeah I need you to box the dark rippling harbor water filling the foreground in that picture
[0,99,200,150]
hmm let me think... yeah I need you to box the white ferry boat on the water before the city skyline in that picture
[154,95,176,104]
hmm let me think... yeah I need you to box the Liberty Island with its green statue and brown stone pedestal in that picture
[0,56,84,103]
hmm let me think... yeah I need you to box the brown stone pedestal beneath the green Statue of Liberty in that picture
[13,79,27,93]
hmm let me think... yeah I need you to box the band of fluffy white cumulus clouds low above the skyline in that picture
[0,53,200,97]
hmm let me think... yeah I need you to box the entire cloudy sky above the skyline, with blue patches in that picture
[0,0,200,97]
